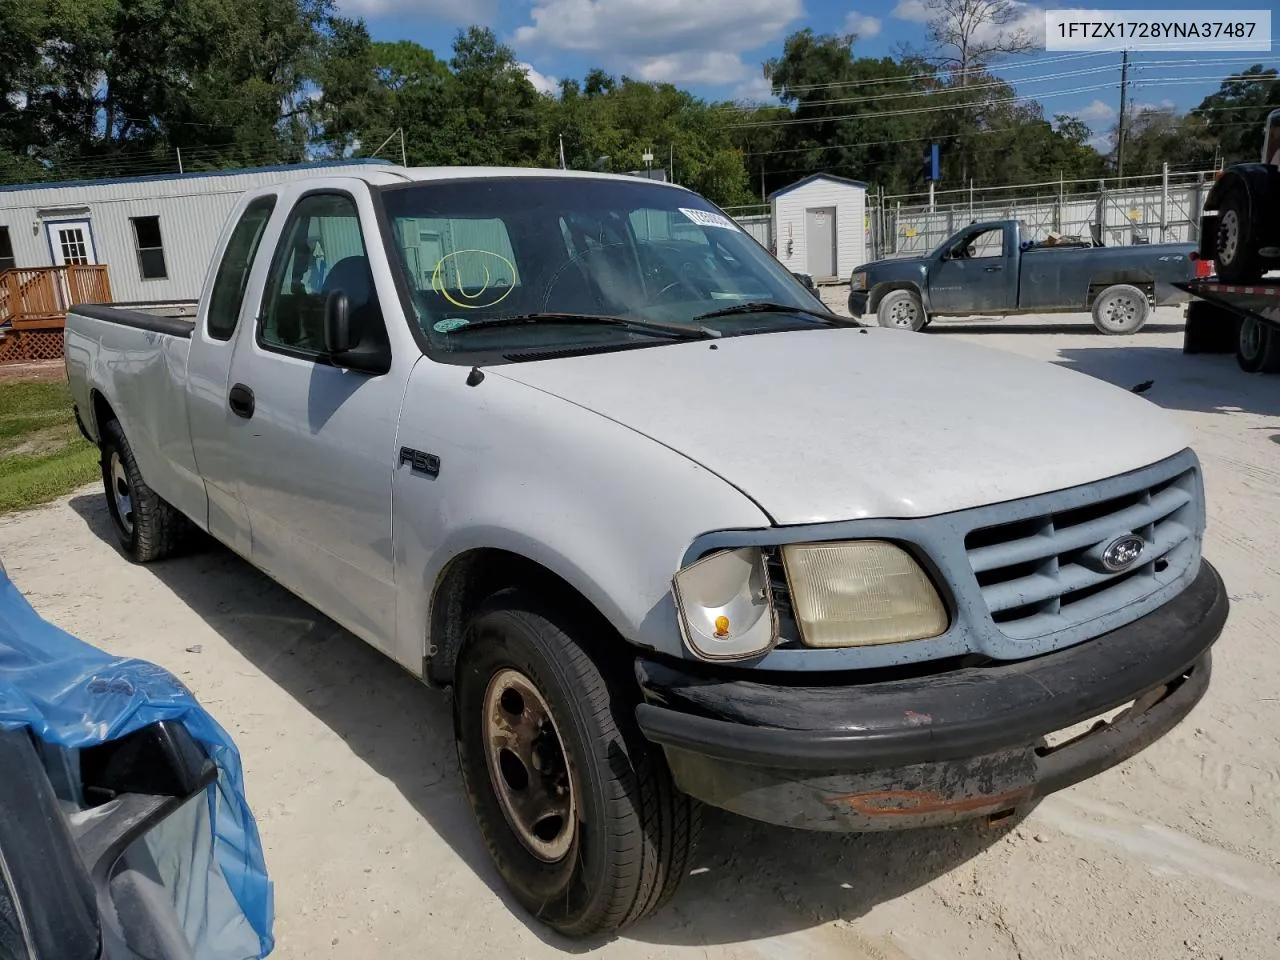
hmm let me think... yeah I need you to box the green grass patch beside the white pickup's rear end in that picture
[0,381,99,513]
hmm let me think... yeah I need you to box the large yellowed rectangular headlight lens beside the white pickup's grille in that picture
[782,540,948,646]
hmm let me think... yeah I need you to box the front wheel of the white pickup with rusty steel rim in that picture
[453,590,700,937]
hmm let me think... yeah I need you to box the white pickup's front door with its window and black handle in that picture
[224,184,412,650]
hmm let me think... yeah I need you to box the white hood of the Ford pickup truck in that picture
[489,328,1189,524]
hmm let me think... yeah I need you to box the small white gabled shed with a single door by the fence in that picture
[769,173,867,282]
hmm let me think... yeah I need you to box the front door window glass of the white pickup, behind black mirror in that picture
[259,193,381,356]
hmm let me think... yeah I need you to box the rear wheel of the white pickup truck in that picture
[100,420,193,563]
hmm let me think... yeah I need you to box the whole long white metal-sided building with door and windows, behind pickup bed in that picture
[0,160,387,303]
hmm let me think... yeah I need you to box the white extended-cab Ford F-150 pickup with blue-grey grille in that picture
[65,168,1228,936]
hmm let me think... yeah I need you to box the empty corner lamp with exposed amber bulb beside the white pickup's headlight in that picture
[673,547,778,660]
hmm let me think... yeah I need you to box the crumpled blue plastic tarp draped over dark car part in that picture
[0,576,274,960]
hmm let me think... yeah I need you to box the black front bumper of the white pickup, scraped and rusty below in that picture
[636,562,1229,831]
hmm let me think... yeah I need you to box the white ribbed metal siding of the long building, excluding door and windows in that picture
[0,164,389,303]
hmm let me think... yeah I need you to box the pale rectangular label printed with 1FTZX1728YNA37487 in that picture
[1044,10,1271,52]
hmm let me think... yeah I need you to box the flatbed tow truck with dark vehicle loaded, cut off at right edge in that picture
[1175,110,1280,374]
